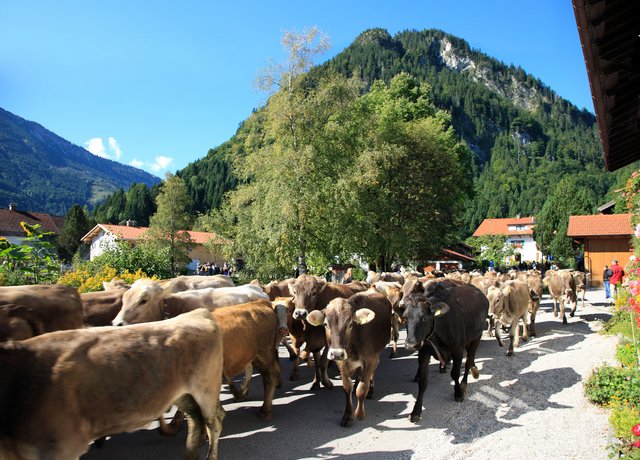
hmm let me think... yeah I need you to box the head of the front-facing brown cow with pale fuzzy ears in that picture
[307,298,376,361]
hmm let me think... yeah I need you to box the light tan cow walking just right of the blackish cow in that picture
[487,280,531,356]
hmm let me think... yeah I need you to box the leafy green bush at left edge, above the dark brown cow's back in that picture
[0,222,60,284]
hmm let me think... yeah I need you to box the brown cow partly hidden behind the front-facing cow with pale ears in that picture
[289,275,362,389]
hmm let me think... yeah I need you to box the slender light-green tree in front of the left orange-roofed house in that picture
[147,173,192,276]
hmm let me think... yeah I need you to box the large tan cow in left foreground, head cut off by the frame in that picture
[0,309,224,460]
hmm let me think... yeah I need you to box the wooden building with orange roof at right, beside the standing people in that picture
[567,214,633,286]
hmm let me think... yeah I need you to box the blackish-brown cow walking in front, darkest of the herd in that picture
[402,281,489,422]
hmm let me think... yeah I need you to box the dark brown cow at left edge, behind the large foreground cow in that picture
[0,284,82,341]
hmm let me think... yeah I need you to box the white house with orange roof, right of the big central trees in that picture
[473,216,542,262]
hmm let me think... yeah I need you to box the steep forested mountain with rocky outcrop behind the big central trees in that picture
[178,29,628,234]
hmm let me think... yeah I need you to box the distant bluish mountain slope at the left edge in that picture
[0,108,160,215]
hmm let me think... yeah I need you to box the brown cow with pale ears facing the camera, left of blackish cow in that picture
[307,291,391,426]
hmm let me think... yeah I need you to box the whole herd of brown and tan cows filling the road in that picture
[0,270,584,460]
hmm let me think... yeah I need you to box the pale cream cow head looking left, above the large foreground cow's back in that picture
[112,279,164,326]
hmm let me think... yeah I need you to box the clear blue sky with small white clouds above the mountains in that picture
[0,0,593,177]
